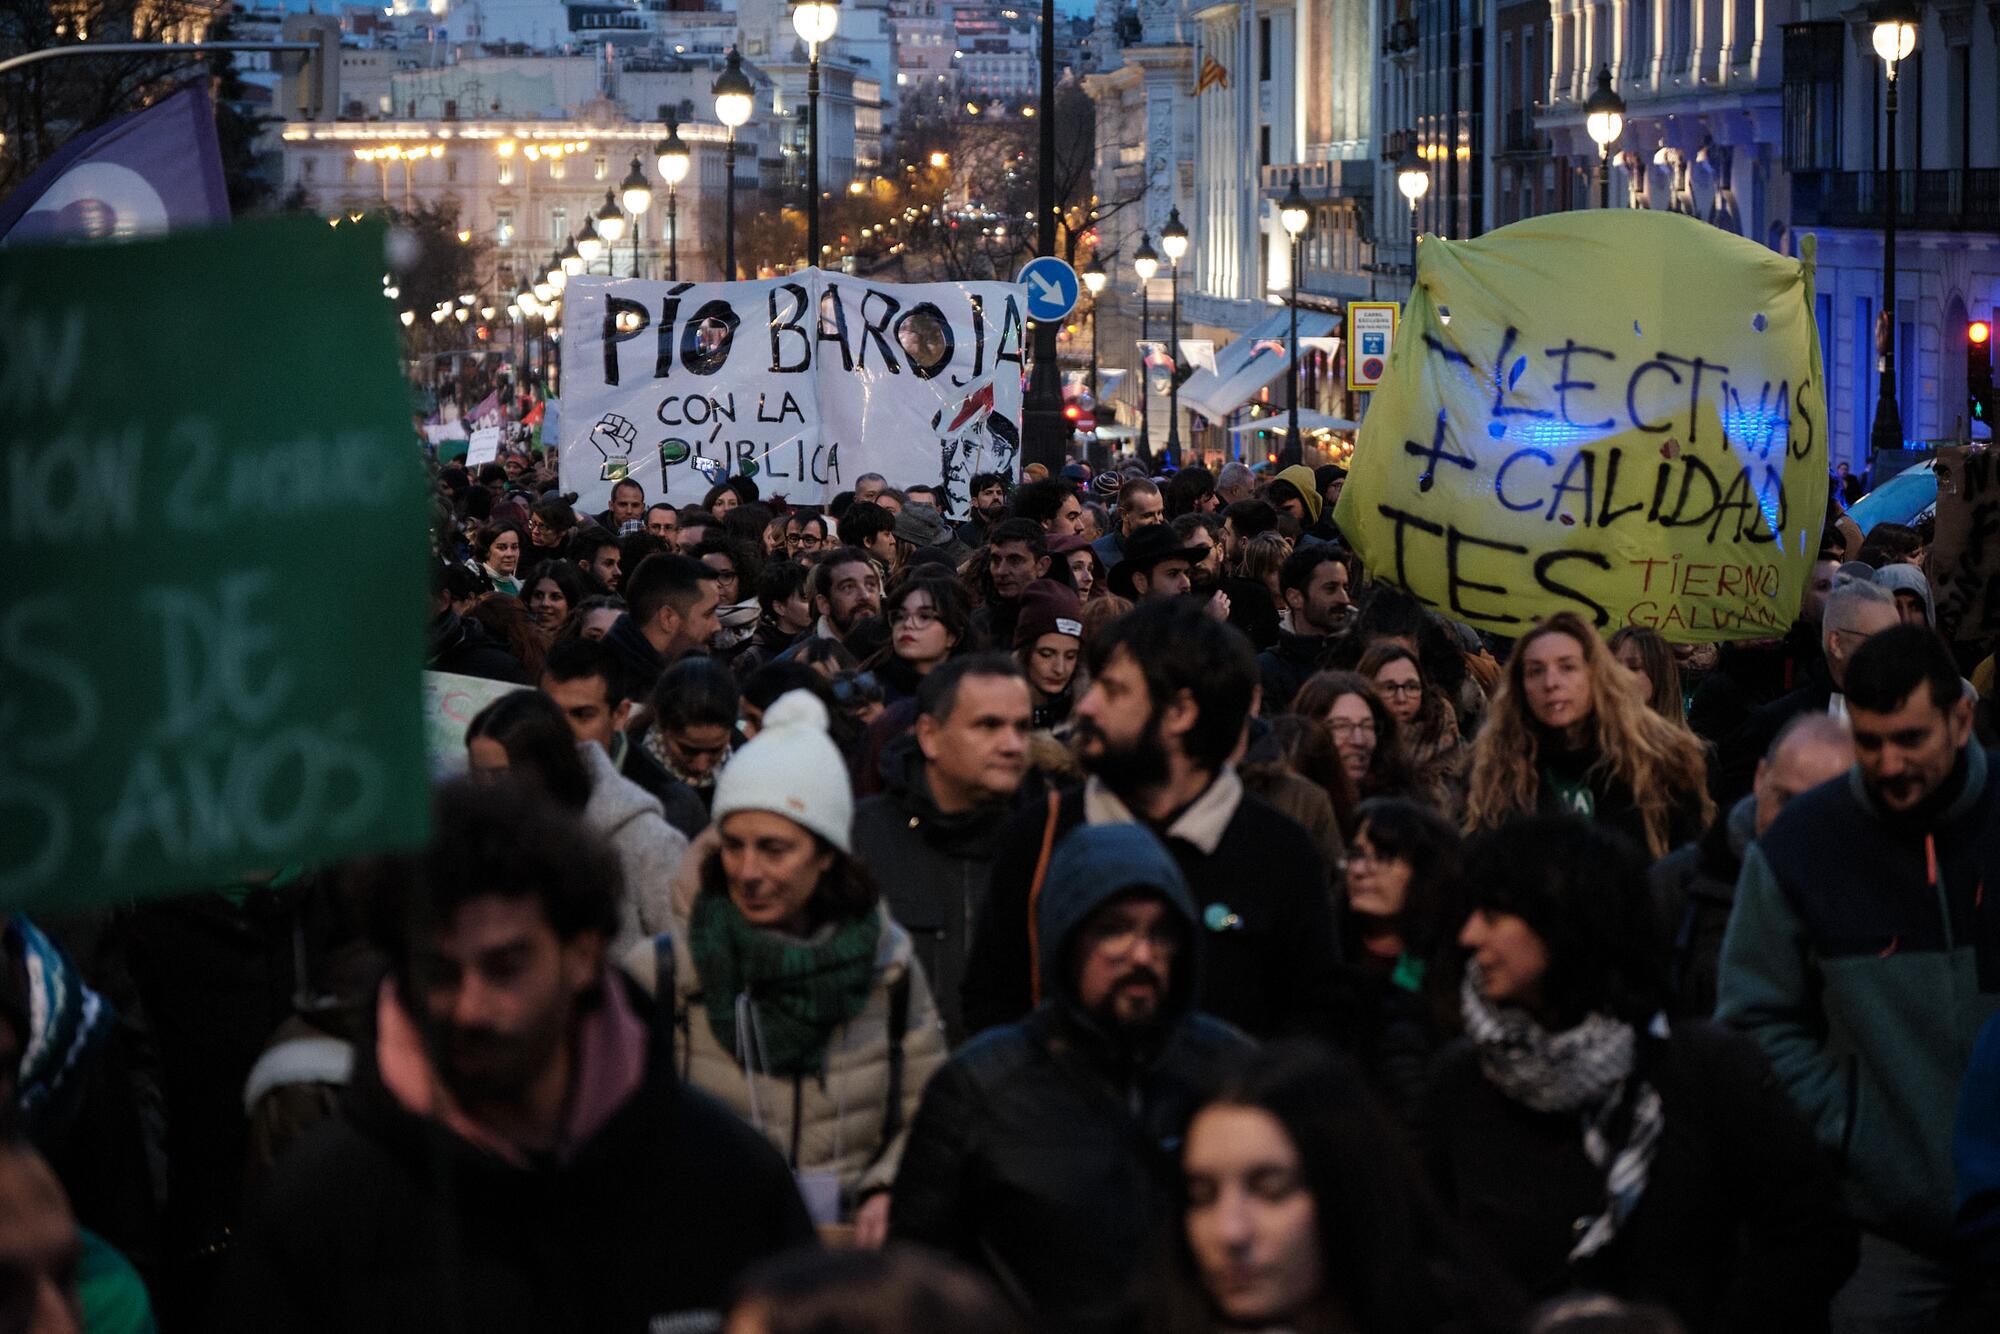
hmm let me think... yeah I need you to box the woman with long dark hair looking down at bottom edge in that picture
[1146,1042,1520,1334]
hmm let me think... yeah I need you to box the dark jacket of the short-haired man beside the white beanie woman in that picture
[852,734,1014,1048]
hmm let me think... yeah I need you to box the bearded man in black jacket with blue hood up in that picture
[890,824,1248,1334]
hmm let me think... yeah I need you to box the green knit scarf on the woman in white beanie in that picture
[688,890,882,1074]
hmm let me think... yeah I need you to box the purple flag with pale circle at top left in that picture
[0,82,230,246]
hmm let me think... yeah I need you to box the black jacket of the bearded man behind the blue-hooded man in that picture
[964,776,1342,1038]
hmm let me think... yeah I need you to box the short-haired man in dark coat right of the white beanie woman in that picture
[854,654,1034,1048]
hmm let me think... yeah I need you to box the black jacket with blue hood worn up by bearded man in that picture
[890,828,1252,1334]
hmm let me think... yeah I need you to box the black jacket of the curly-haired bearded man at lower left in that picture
[222,976,812,1334]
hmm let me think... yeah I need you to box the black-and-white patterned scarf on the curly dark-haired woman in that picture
[1458,962,1666,1262]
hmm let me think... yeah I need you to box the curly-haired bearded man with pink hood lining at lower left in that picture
[220,780,812,1334]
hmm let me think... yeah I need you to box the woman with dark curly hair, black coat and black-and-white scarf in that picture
[1424,820,1856,1330]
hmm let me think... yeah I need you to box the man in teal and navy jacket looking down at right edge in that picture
[1716,626,2000,1330]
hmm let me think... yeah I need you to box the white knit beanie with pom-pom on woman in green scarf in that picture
[712,690,854,852]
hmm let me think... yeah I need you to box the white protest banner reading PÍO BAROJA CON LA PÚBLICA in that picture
[564,270,1024,514]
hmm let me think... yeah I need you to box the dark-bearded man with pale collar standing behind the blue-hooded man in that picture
[964,600,1340,1038]
